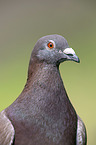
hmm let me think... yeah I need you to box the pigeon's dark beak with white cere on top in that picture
[63,48,80,63]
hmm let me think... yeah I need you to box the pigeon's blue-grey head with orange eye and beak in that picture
[31,34,80,65]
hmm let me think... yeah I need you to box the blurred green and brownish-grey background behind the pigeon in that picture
[0,0,96,145]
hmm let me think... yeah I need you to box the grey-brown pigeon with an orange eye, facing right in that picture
[0,34,87,145]
